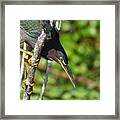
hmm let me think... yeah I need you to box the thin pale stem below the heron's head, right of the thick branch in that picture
[40,60,51,100]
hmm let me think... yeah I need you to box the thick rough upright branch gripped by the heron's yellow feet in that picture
[23,32,46,100]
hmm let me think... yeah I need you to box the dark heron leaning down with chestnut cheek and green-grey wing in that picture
[20,20,75,87]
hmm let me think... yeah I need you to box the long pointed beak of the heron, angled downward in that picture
[56,58,75,88]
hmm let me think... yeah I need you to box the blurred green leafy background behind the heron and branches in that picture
[20,20,100,100]
